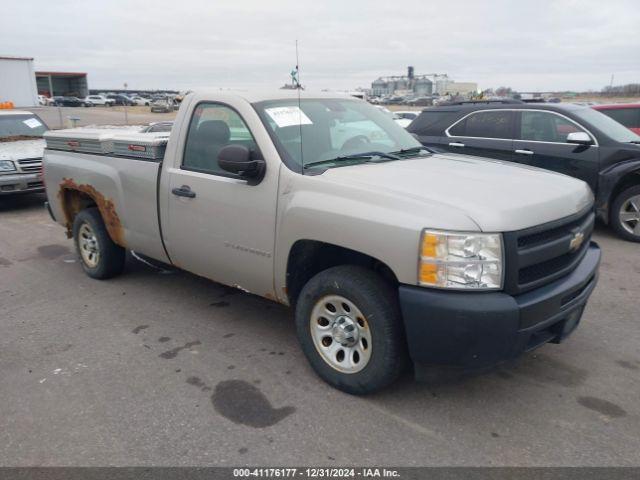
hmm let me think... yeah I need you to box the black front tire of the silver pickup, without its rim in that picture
[295,265,407,395]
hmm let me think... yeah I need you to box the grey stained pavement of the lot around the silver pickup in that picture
[0,191,640,466]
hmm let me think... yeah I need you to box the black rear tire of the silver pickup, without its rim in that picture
[73,207,126,280]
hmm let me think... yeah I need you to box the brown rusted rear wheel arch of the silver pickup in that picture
[58,178,126,247]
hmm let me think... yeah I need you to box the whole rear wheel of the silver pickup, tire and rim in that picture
[73,208,125,280]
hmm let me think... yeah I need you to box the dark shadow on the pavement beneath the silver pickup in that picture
[126,251,608,410]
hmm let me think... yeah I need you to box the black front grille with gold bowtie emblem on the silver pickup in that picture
[504,209,595,294]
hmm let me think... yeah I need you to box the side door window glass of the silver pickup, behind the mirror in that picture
[182,103,257,177]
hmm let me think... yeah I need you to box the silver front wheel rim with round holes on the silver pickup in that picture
[309,295,373,374]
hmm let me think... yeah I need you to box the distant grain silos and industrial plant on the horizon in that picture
[371,67,478,97]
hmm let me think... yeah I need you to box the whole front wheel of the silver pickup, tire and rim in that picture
[296,265,406,395]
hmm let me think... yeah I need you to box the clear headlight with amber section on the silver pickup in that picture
[418,230,504,290]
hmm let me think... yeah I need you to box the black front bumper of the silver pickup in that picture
[399,242,600,379]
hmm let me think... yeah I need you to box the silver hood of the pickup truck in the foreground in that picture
[322,154,593,232]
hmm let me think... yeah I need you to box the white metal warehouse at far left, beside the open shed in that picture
[0,55,38,107]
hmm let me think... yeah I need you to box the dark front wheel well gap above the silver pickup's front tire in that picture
[287,240,398,306]
